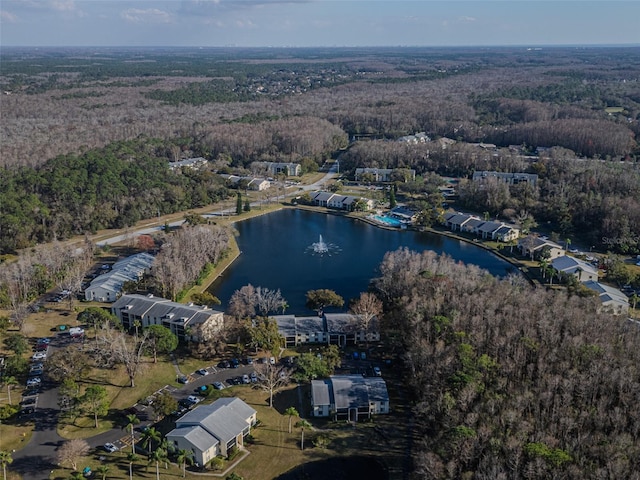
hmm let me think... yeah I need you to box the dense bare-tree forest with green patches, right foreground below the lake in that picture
[374,250,640,480]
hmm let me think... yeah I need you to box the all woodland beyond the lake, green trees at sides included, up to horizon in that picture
[0,48,640,252]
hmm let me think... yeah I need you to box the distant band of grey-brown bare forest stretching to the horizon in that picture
[0,48,640,166]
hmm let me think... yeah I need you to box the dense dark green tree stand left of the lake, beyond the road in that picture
[0,139,228,253]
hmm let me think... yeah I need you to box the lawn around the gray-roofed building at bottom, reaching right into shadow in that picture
[50,378,405,480]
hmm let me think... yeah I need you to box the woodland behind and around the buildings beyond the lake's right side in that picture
[340,140,640,253]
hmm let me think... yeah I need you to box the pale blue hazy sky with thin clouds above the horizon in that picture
[0,0,640,47]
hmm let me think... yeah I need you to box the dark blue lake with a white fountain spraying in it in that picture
[209,209,513,315]
